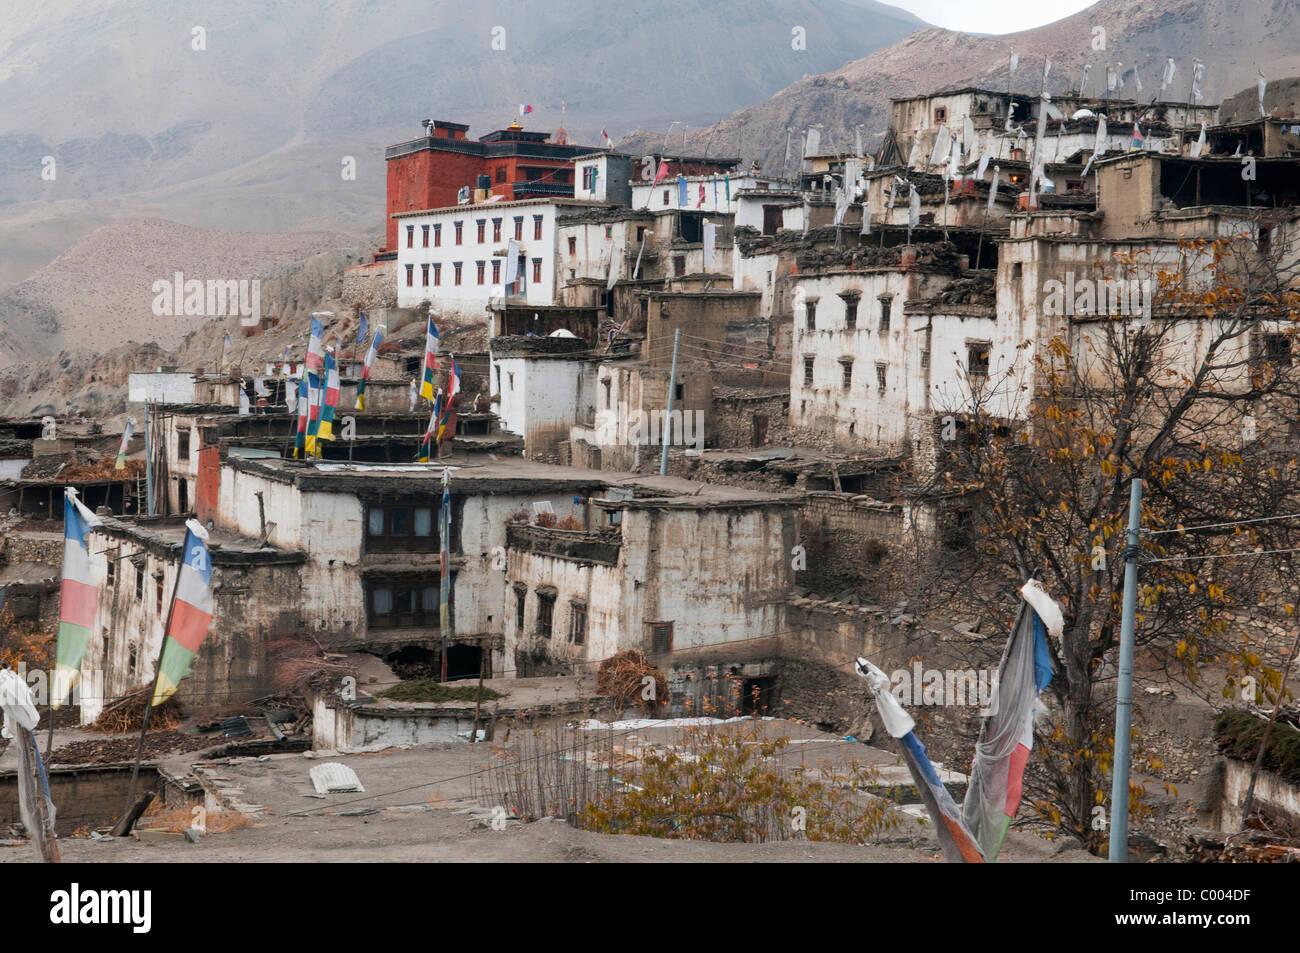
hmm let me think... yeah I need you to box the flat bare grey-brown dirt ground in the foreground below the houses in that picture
[0,723,1100,863]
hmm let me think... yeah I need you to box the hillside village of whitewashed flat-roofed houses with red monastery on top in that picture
[0,70,1300,862]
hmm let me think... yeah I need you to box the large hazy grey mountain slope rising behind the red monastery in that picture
[0,0,924,276]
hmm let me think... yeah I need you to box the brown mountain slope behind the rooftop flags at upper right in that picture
[619,0,1300,173]
